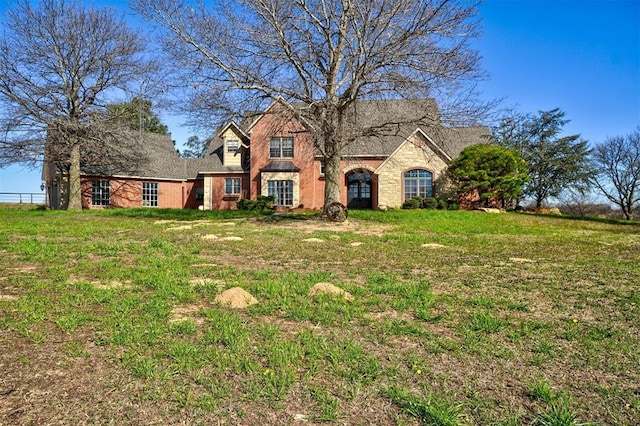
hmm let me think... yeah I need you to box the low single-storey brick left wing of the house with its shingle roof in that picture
[42,132,211,209]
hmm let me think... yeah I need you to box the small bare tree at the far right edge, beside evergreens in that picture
[592,128,640,220]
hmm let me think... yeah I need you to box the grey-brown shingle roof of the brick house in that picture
[81,99,489,180]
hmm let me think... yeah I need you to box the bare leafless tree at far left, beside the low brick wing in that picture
[0,0,155,209]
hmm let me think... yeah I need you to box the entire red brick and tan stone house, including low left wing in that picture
[45,100,489,210]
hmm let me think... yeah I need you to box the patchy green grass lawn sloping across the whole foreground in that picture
[0,208,640,425]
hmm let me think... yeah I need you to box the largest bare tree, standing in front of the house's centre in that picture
[132,0,483,210]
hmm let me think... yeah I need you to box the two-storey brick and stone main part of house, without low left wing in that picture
[201,100,489,209]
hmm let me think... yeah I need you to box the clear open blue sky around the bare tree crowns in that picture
[0,0,640,192]
